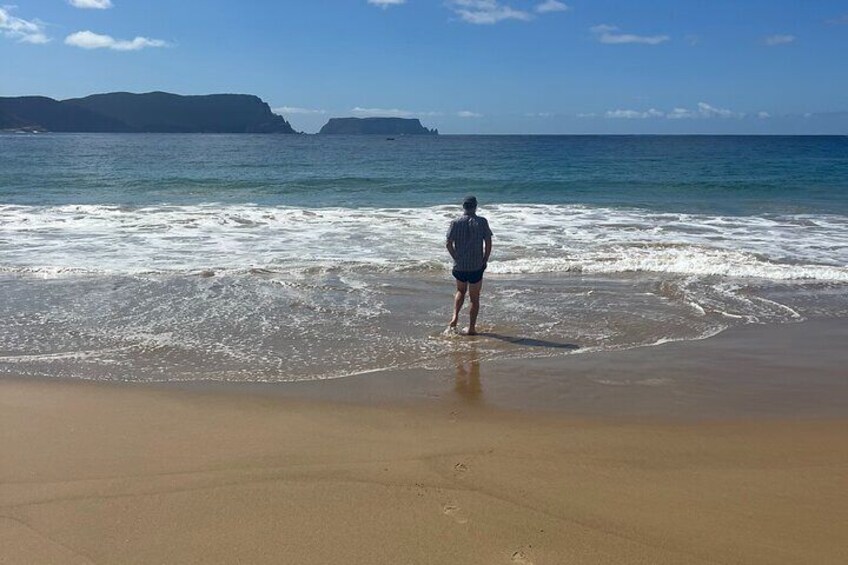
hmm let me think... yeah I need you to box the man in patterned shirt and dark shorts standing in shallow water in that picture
[446,196,492,335]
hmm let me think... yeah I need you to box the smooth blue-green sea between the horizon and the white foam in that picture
[0,134,848,214]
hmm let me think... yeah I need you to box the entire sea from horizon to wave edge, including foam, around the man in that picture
[0,134,848,382]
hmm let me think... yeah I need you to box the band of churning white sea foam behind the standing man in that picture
[0,203,848,282]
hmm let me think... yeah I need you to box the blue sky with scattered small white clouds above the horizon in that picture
[0,0,848,134]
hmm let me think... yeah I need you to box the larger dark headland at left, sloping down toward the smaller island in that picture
[0,92,297,133]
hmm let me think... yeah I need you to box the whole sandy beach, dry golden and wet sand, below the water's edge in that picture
[0,320,848,564]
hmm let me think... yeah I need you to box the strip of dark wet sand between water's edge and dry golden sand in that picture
[16,318,848,422]
